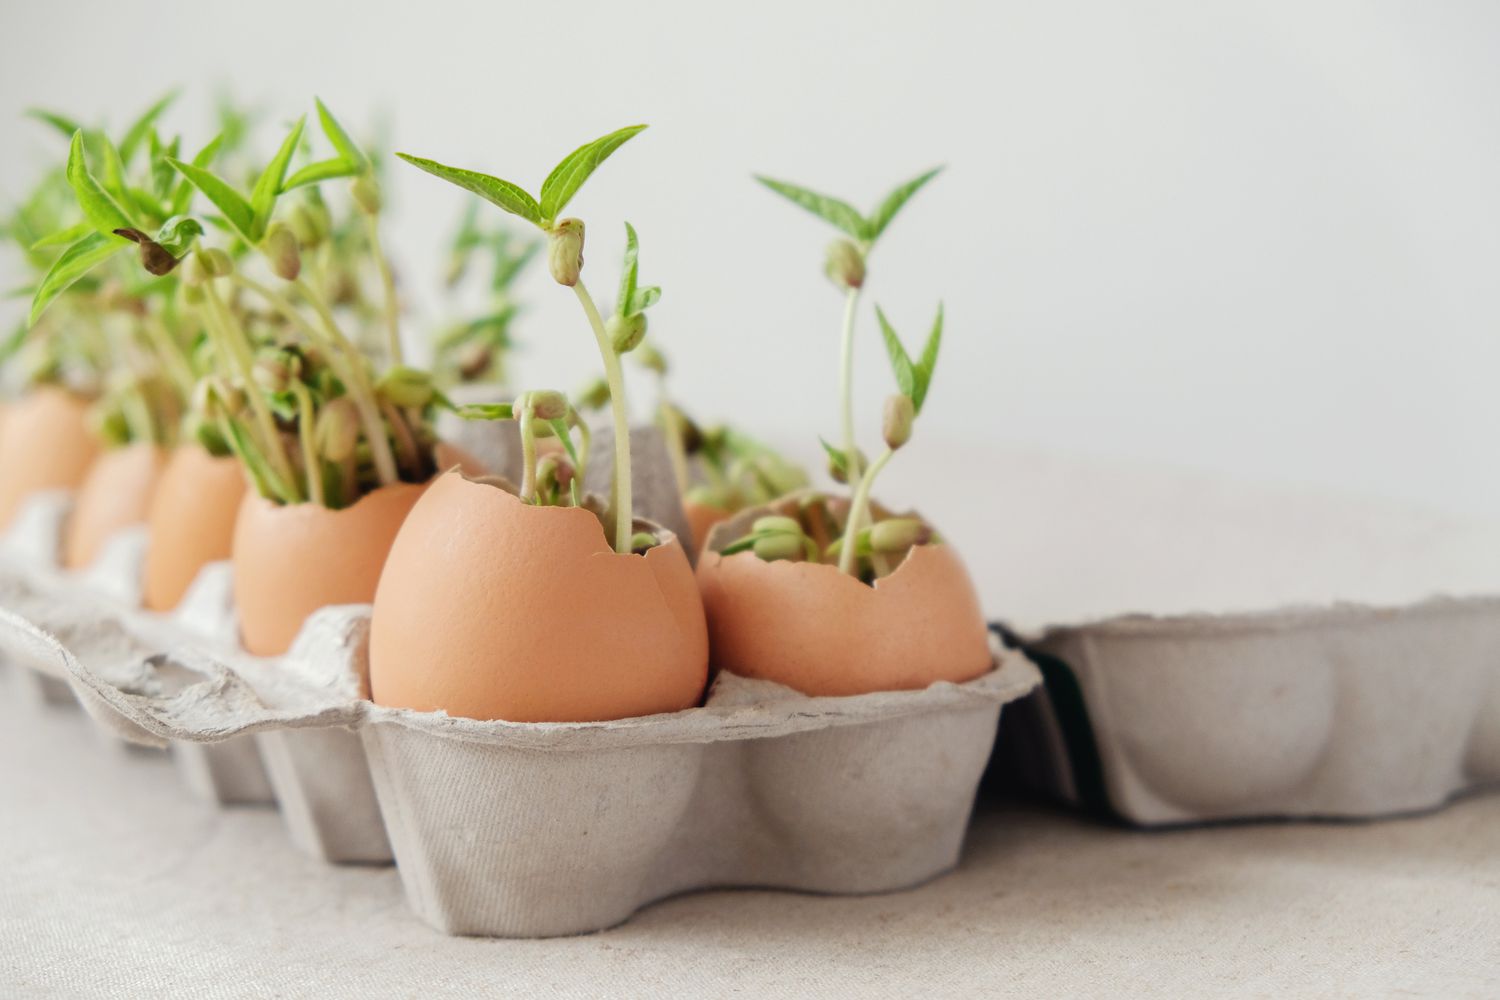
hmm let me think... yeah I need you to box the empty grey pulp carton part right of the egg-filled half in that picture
[998,597,1500,826]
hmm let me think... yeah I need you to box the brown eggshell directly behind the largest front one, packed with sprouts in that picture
[231,483,428,657]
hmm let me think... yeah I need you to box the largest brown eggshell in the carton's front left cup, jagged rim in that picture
[371,474,708,723]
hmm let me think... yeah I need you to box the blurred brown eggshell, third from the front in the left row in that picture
[144,444,246,612]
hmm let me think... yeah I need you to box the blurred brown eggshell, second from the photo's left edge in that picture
[63,442,167,570]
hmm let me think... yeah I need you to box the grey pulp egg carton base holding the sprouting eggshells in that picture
[51,578,1040,937]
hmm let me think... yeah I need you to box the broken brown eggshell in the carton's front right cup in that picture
[698,544,992,696]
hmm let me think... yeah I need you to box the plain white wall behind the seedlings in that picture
[0,0,1500,524]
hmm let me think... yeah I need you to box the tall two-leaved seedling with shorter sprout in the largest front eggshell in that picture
[398,124,660,553]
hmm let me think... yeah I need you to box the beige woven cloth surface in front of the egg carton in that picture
[0,669,1500,1000]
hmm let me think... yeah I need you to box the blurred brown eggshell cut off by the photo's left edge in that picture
[0,385,99,529]
